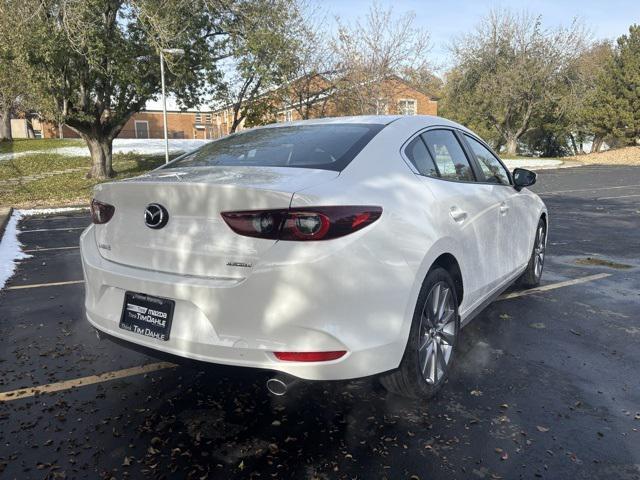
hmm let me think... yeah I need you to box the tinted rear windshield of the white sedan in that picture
[164,123,384,171]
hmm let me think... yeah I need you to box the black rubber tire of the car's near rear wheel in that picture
[379,267,460,399]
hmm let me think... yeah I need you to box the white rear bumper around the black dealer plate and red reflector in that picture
[80,227,413,380]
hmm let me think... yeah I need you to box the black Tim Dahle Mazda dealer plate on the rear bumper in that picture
[120,292,176,342]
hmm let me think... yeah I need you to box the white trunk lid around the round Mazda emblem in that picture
[95,166,339,278]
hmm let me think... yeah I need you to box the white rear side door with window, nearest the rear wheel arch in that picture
[405,128,508,307]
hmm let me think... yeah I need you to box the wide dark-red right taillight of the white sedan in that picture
[222,206,382,241]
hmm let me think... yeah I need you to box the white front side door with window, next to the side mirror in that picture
[464,134,535,277]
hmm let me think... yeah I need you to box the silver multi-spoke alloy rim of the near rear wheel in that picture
[418,282,457,385]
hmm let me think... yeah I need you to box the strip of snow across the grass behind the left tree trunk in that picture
[0,138,209,161]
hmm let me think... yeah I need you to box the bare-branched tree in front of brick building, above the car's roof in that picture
[331,3,431,114]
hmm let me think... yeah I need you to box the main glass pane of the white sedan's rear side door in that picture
[421,130,475,182]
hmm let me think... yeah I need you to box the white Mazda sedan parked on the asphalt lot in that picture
[80,116,548,398]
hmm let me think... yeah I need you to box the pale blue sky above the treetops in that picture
[318,0,640,70]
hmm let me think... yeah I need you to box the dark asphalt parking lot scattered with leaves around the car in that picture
[0,166,640,480]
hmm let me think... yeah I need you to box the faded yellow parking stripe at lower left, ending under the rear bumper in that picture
[0,362,177,403]
